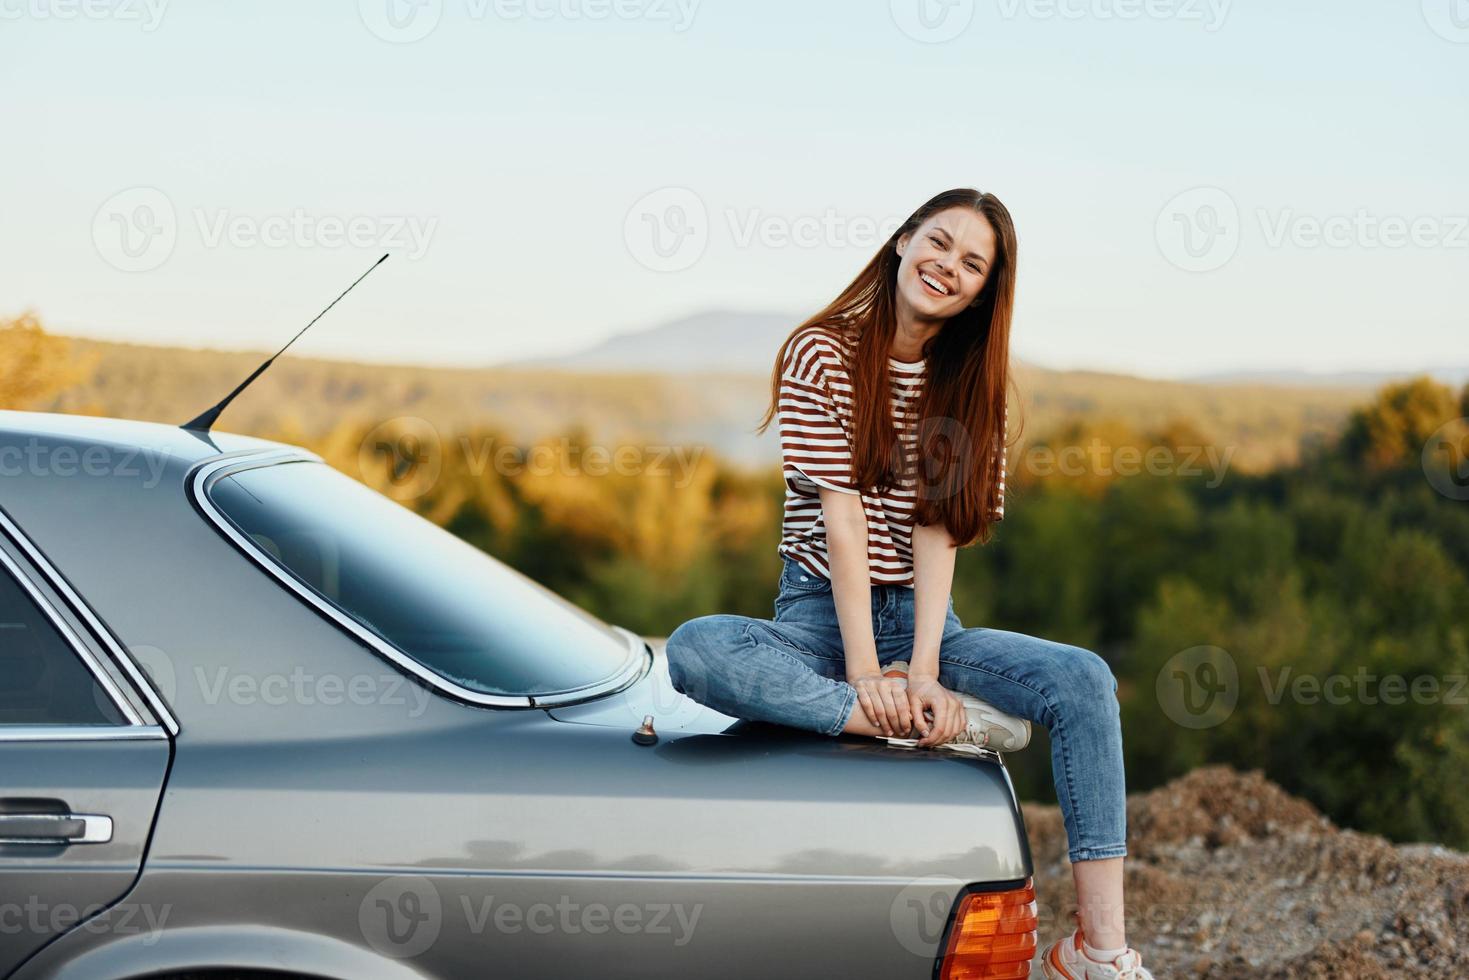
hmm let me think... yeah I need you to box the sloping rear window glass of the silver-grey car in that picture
[206,460,635,696]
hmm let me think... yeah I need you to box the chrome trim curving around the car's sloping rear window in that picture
[185,447,652,708]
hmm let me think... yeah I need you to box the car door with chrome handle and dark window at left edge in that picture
[0,519,170,977]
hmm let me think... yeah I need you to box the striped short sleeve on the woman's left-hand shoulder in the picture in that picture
[779,335,859,494]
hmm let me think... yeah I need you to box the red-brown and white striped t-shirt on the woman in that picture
[779,326,1005,589]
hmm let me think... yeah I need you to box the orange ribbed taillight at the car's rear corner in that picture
[939,879,1036,980]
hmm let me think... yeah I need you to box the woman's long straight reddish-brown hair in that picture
[755,187,1018,547]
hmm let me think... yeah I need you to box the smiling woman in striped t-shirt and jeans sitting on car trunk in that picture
[667,188,1152,980]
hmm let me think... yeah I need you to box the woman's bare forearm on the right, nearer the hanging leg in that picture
[908,523,967,745]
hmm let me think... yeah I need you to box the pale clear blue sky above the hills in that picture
[0,0,1469,378]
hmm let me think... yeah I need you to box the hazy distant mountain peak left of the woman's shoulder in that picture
[497,310,805,375]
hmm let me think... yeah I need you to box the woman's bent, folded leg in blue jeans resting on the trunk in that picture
[665,614,862,735]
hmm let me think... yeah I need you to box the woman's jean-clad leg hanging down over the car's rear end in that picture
[939,627,1127,949]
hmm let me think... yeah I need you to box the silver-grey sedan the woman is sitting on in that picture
[0,411,1036,980]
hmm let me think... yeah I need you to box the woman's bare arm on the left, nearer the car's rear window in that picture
[820,486,914,735]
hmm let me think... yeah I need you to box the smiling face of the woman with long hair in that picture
[898,207,995,319]
